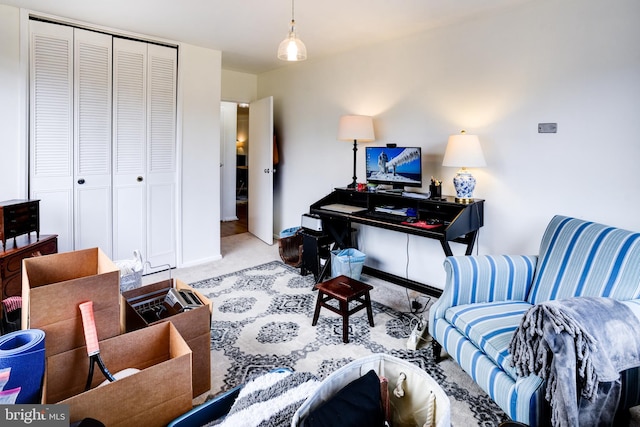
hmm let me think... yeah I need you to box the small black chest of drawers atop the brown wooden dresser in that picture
[0,199,40,250]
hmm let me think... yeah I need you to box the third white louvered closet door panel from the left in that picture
[113,38,148,259]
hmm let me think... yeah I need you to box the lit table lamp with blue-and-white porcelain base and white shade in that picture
[442,130,487,203]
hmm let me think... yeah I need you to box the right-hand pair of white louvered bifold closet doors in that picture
[113,38,177,266]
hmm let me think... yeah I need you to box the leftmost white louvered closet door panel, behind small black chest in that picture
[29,21,73,252]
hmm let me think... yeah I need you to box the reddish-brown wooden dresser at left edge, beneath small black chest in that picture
[0,234,58,299]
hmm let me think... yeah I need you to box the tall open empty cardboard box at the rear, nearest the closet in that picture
[22,248,123,356]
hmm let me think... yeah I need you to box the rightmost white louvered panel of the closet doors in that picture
[147,44,177,267]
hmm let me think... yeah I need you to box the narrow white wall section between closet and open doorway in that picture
[179,44,222,266]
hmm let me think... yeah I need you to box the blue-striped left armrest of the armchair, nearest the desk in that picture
[429,255,538,319]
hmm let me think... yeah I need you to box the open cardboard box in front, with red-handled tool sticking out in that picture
[43,322,193,427]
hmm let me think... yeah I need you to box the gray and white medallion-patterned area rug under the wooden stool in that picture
[191,262,508,427]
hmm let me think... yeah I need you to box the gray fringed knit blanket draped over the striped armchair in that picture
[509,297,640,426]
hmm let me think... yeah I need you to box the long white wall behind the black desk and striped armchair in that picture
[258,0,640,287]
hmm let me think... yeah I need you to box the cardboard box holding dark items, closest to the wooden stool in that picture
[122,279,212,397]
